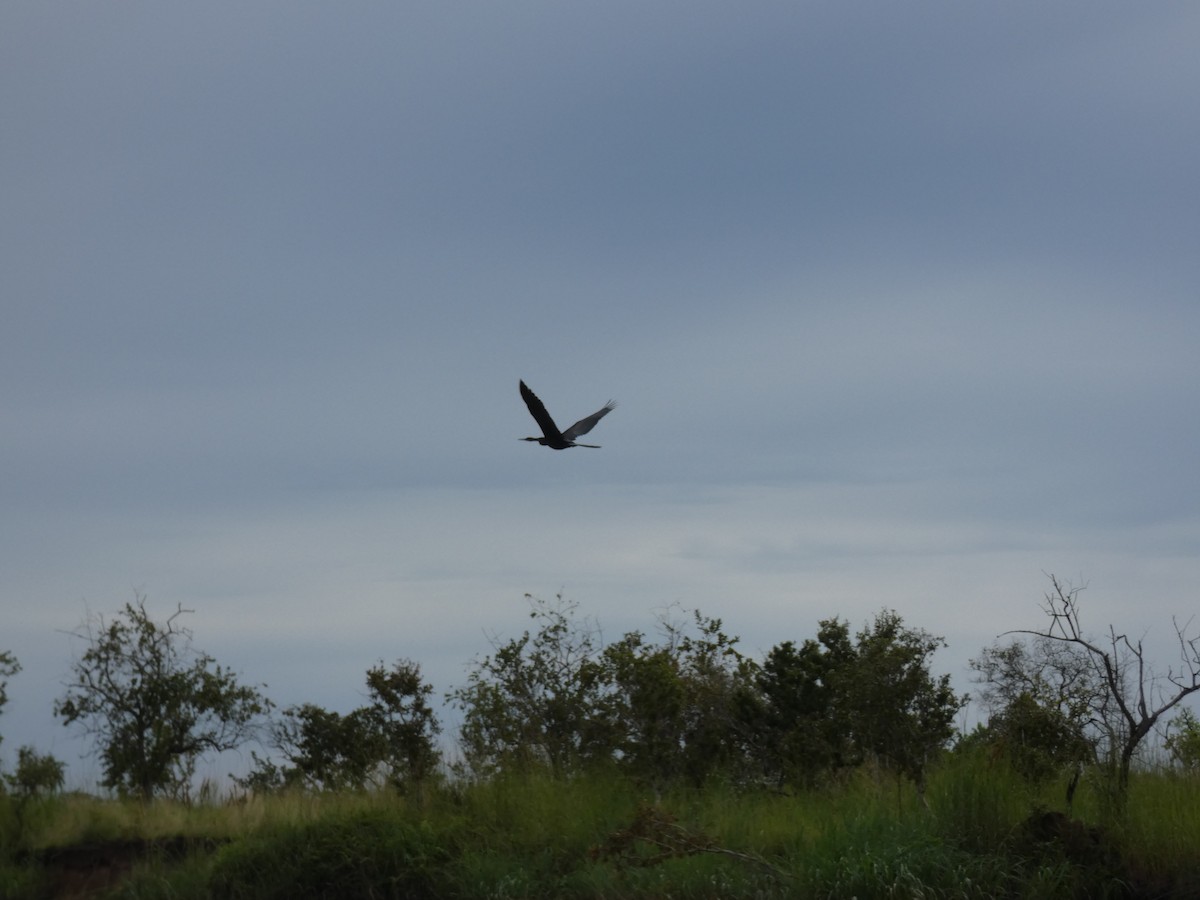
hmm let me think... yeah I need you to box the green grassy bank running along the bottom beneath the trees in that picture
[0,760,1200,900]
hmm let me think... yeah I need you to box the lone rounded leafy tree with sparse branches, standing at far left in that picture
[54,596,272,800]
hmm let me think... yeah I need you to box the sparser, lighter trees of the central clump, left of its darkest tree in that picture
[449,596,752,790]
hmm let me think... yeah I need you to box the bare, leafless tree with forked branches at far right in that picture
[1008,575,1200,799]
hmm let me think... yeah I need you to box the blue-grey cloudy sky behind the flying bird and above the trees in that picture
[0,0,1200,782]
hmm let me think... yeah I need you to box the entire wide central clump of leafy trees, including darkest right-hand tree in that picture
[450,598,966,793]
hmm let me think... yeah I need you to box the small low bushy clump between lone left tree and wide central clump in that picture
[246,660,440,791]
